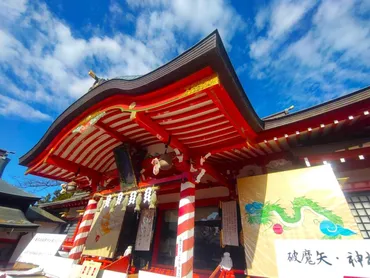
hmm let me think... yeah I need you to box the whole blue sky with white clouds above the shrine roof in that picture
[0,0,370,195]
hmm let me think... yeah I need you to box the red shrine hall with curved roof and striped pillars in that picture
[20,31,370,277]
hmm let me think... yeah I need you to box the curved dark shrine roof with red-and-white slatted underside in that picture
[20,31,370,185]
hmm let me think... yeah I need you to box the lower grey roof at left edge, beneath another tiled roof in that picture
[0,207,39,229]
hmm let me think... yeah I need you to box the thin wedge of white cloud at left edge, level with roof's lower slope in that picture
[0,95,51,121]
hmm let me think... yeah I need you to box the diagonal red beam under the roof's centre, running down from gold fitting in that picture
[131,112,188,154]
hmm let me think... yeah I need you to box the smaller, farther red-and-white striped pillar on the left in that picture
[69,199,97,260]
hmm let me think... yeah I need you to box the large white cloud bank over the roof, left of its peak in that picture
[0,0,244,119]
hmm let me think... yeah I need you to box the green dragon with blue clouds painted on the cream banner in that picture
[245,197,356,239]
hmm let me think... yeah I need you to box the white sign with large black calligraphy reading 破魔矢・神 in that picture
[275,239,370,278]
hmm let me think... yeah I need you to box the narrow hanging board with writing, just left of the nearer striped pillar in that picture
[135,209,155,251]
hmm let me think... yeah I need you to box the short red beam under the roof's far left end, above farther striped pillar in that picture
[45,155,101,180]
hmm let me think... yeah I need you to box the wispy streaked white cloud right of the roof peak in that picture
[244,0,370,108]
